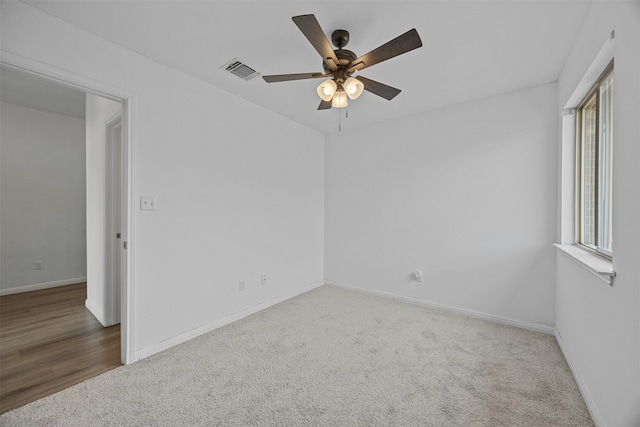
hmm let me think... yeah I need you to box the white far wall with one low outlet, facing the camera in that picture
[325,84,557,331]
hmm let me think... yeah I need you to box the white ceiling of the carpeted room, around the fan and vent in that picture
[24,0,590,134]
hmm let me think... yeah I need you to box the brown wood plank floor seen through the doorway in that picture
[0,283,120,413]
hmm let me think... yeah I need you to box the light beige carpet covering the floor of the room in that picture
[0,286,593,427]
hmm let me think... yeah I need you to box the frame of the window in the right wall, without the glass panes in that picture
[575,59,615,261]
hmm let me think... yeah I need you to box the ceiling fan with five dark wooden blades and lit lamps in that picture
[262,15,422,110]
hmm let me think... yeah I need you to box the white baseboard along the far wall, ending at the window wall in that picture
[325,281,555,335]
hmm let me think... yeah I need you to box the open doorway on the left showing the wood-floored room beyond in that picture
[0,65,127,413]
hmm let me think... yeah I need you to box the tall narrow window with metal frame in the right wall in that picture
[576,63,614,258]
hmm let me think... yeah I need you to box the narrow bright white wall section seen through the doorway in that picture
[85,94,122,325]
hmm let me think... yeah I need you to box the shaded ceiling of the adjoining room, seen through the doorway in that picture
[0,67,86,119]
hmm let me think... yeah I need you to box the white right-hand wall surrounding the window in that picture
[556,2,640,426]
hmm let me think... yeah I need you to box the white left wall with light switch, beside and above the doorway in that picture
[1,2,324,357]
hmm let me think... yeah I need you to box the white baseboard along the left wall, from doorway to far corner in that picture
[133,282,324,361]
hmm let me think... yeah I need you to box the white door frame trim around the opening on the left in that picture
[0,50,135,364]
